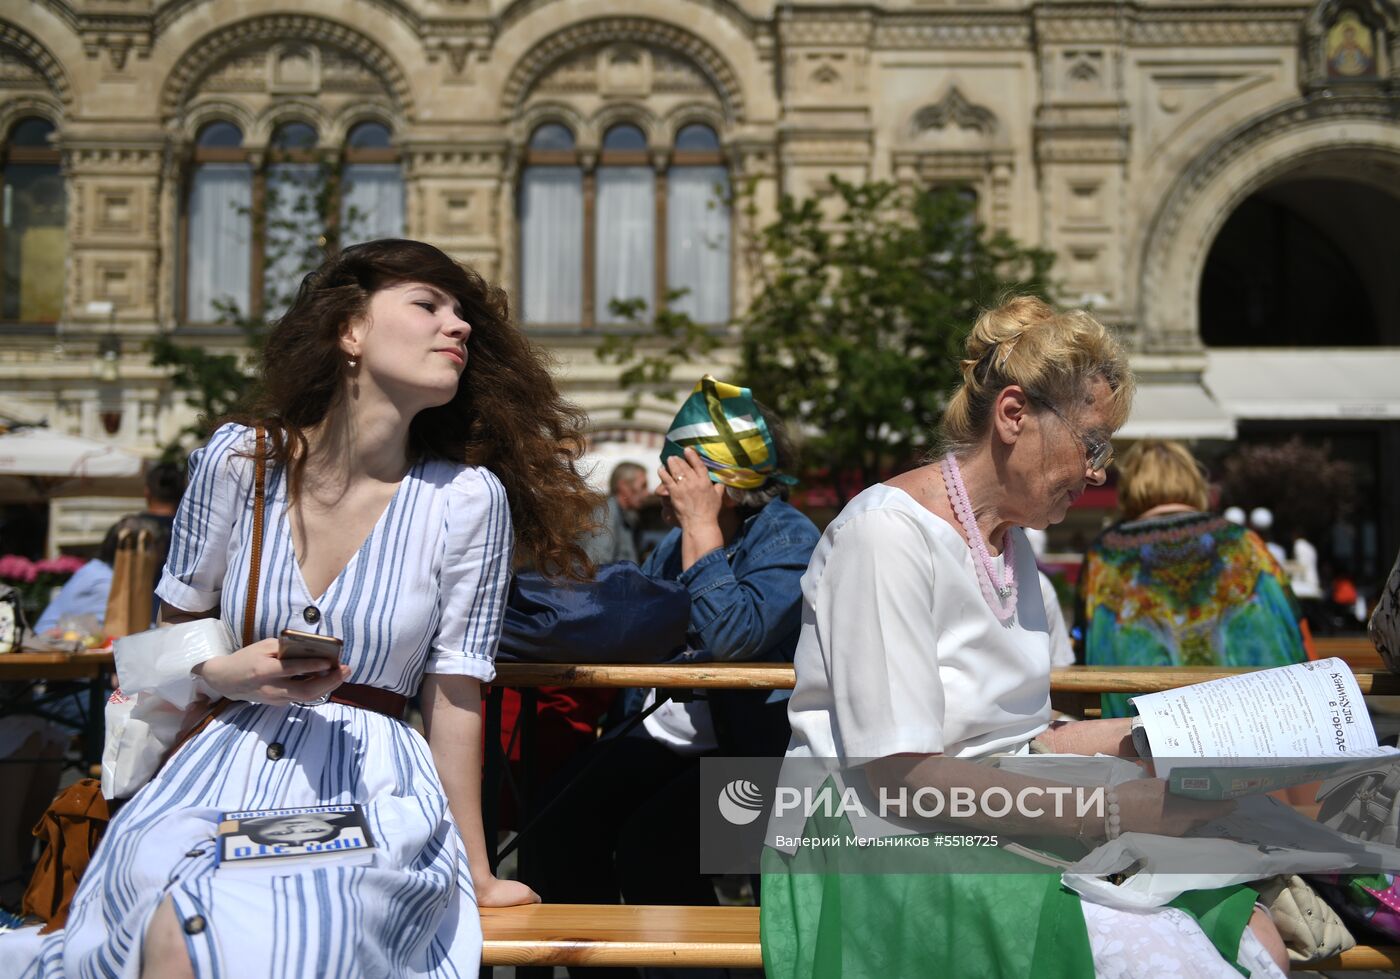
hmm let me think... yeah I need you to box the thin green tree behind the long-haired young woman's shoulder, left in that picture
[150,161,352,462]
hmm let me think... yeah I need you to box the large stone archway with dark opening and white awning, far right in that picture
[1138,103,1400,616]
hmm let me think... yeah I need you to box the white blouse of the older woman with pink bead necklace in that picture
[788,485,1050,765]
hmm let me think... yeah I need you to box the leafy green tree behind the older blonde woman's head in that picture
[599,176,1054,503]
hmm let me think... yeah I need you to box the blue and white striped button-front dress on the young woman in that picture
[21,426,512,979]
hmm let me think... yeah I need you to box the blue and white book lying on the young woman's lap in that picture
[218,805,375,873]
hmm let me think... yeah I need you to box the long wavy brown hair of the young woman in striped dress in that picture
[235,238,599,578]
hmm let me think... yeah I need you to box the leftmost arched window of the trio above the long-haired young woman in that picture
[183,122,253,324]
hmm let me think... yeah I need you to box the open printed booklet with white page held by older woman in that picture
[1133,658,1400,798]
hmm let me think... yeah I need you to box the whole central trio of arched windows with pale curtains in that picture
[519,123,732,326]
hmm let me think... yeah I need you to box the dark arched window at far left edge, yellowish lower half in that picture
[0,116,67,324]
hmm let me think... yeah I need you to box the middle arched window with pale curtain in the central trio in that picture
[594,123,657,324]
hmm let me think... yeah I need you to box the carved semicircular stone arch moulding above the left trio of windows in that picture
[160,14,413,118]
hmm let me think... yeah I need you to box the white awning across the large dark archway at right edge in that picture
[1204,349,1400,419]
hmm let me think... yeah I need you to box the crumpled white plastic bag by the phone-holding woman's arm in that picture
[102,619,234,798]
